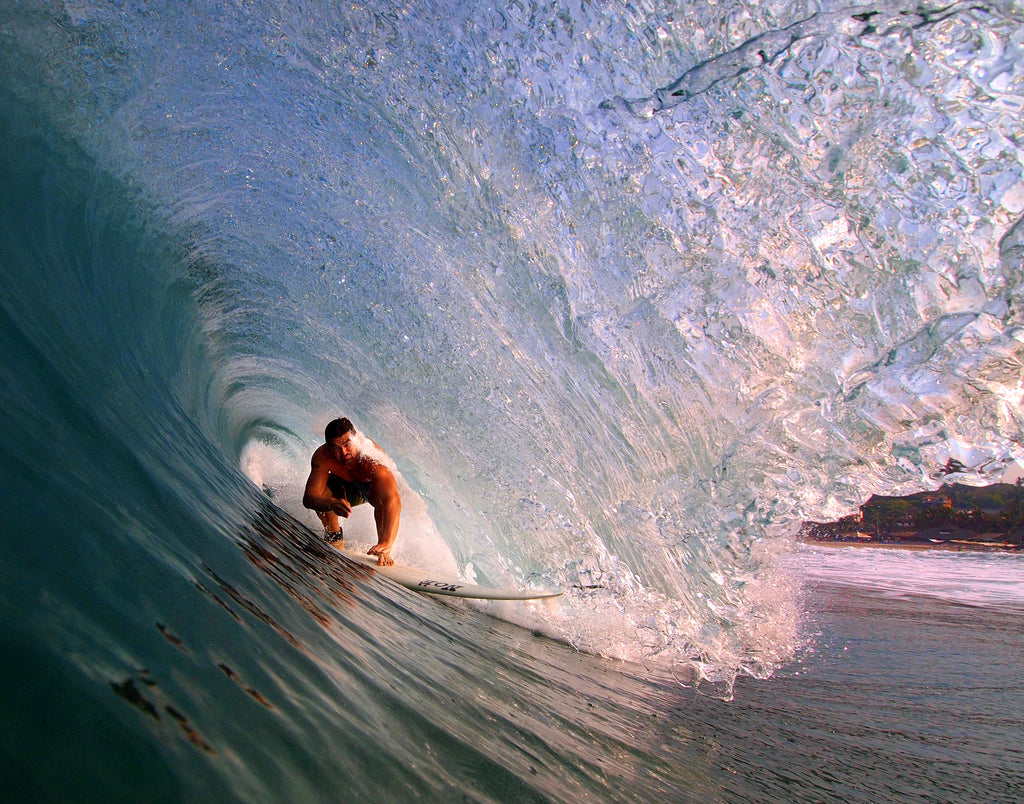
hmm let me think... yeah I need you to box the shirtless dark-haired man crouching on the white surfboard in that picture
[302,419,401,566]
